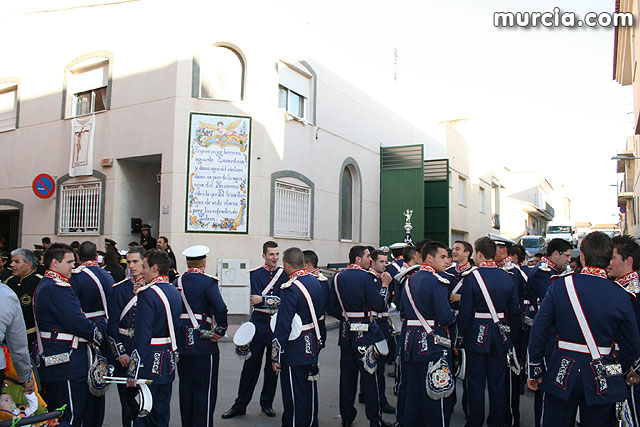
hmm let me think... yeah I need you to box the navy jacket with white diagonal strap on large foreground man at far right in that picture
[529,267,640,405]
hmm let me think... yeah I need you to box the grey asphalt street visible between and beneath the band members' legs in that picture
[104,329,533,427]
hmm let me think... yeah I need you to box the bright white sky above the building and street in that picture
[279,0,633,223]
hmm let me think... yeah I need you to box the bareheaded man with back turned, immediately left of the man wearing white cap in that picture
[127,249,182,427]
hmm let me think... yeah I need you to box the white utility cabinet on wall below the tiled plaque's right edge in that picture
[217,259,251,314]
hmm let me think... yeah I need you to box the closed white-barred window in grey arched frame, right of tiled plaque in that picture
[273,181,311,239]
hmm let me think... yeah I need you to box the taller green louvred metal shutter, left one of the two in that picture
[380,145,424,246]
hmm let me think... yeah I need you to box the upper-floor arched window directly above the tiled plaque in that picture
[198,45,244,101]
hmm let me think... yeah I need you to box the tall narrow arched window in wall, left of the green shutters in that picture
[339,157,362,242]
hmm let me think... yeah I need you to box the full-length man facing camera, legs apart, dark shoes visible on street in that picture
[222,241,287,418]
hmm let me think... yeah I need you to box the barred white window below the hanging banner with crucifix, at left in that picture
[58,182,102,234]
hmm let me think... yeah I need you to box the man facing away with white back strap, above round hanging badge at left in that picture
[69,241,114,427]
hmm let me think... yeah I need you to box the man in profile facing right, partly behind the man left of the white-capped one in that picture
[107,246,146,427]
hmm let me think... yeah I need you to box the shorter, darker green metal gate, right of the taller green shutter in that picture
[424,159,449,246]
